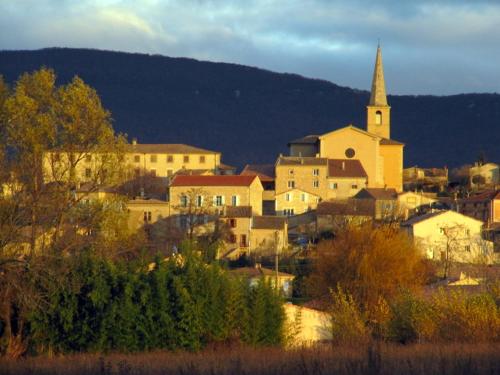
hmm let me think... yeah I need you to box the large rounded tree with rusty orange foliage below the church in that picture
[309,224,427,309]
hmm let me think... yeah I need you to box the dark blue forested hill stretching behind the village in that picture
[0,48,500,167]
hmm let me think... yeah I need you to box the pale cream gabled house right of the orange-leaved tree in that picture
[402,211,493,263]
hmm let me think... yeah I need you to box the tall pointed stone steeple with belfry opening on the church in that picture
[366,44,391,138]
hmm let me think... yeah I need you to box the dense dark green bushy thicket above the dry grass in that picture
[30,250,284,353]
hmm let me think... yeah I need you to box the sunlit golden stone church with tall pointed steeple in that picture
[288,46,404,192]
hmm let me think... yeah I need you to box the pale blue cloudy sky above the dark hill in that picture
[0,0,500,95]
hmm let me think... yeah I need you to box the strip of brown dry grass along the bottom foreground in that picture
[0,344,500,375]
